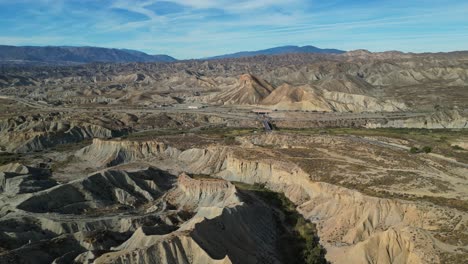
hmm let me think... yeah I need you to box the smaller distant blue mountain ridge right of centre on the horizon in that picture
[206,46,346,59]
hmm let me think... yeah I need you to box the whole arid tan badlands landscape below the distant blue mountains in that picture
[0,47,468,264]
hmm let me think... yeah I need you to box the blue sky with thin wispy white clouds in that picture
[0,0,468,59]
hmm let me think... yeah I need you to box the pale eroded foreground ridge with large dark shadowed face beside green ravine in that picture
[91,174,280,263]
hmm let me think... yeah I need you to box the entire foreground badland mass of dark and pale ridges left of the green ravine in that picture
[0,166,284,263]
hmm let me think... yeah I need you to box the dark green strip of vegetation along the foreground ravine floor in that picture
[233,182,328,264]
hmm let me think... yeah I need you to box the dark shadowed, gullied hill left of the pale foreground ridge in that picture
[18,169,176,214]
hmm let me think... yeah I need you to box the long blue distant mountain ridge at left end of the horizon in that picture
[0,45,176,64]
